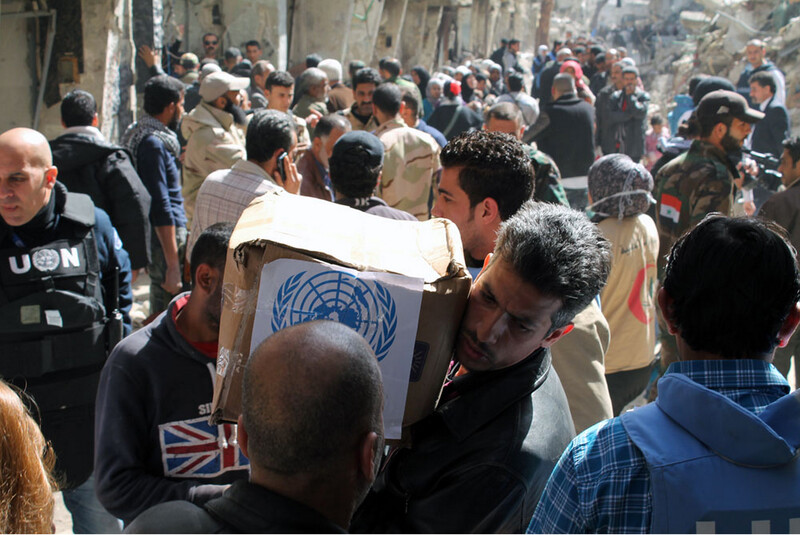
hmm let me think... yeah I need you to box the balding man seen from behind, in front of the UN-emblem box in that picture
[127,321,383,533]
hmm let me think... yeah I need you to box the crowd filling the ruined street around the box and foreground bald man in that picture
[0,26,800,533]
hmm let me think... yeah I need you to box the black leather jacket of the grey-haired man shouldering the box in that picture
[351,348,575,533]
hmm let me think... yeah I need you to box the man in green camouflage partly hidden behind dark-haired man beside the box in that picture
[483,102,569,206]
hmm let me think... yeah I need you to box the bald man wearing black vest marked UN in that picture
[0,128,132,533]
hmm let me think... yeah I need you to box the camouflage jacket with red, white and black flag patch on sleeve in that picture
[655,140,735,272]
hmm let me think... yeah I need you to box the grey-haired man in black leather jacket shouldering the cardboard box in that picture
[352,202,610,533]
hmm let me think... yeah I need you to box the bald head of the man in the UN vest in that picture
[0,128,58,227]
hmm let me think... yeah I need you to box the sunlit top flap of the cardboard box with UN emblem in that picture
[230,191,465,284]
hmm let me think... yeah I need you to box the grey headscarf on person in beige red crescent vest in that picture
[587,154,655,219]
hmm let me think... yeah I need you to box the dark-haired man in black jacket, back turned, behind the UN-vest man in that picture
[50,89,150,271]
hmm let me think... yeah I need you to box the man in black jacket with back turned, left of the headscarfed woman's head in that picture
[534,73,594,178]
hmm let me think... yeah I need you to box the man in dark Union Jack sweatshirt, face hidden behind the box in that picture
[95,223,248,524]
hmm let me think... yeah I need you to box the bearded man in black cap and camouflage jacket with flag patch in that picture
[655,89,764,369]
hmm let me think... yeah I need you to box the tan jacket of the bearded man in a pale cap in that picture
[181,102,247,225]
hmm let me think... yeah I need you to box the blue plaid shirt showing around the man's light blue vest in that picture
[528,360,789,533]
